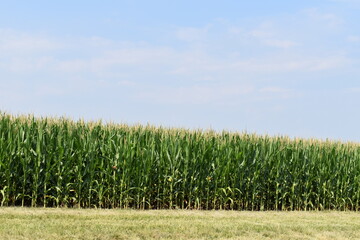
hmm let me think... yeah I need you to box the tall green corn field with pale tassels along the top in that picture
[0,113,360,211]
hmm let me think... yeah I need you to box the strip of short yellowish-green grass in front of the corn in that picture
[0,208,360,240]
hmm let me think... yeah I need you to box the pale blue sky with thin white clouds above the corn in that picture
[0,0,360,142]
